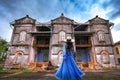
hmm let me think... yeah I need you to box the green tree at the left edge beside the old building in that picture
[0,37,8,61]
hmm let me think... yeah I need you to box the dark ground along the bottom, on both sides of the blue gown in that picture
[0,70,120,80]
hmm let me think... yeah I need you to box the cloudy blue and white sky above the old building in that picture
[0,0,120,43]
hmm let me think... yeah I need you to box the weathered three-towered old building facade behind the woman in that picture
[5,14,116,69]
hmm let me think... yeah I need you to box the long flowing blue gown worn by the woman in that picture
[55,43,84,80]
